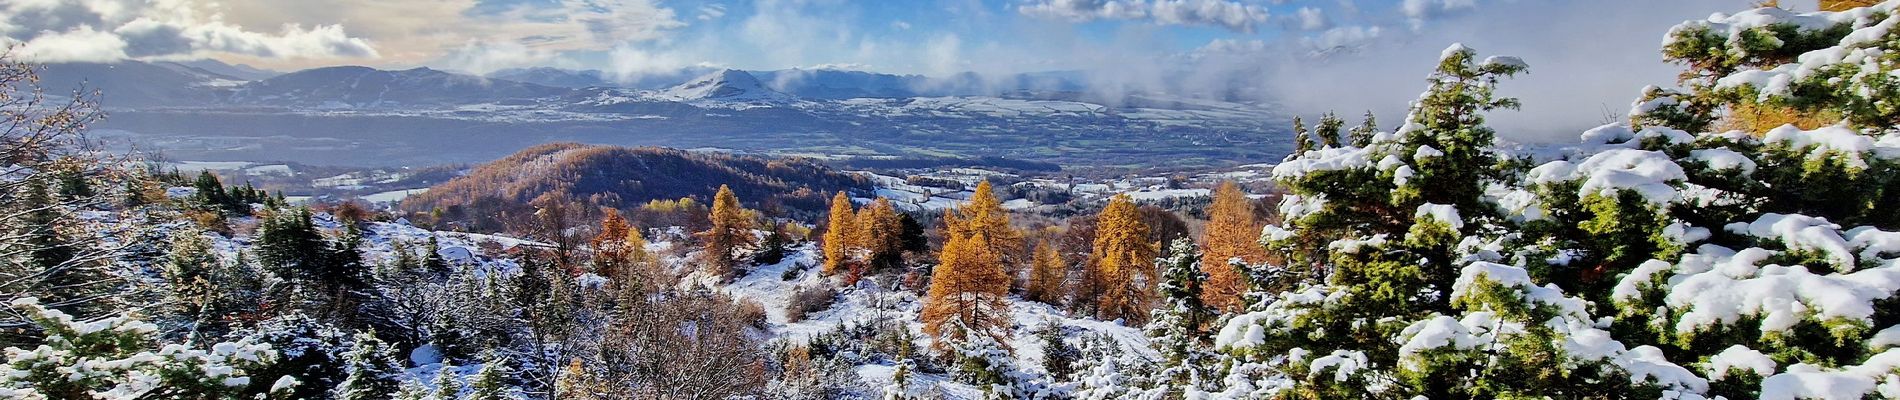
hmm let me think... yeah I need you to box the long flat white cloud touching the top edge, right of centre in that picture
[1017,0,1273,32]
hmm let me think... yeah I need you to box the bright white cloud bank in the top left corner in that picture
[0,0,378,63]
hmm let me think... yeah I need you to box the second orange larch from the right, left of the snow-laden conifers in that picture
[1089,195,1161,326]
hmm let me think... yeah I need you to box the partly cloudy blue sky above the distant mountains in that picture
[0,0,1813,138]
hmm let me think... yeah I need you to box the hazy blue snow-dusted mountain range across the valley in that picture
[59,61,1288,167]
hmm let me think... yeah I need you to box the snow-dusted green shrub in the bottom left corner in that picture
[0,298,296,400]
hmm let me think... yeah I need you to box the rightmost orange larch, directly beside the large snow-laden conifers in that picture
[1201,182,1267,313]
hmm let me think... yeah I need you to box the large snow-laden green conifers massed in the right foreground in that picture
[1216,2,1900,398]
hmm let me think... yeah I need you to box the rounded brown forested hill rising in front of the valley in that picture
[403,142,870,229]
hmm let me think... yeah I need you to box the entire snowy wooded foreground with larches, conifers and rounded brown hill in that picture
[0,2,1900,400]
